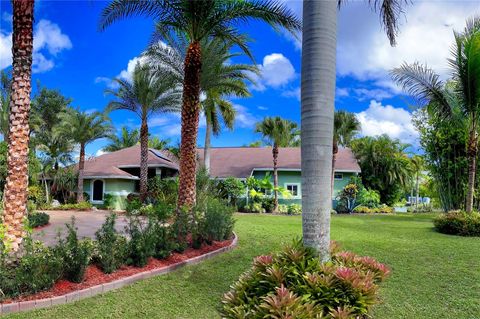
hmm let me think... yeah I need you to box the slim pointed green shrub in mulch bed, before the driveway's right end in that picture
[95,214,127,274]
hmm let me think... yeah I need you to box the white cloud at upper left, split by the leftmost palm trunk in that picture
[0,18,72,73]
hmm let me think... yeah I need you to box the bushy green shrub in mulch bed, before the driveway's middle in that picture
[55,217,94,283]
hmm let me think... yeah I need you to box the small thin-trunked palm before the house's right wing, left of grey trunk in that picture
[255,116,297,212]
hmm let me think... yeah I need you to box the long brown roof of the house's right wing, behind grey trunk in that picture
[197,147,361,178]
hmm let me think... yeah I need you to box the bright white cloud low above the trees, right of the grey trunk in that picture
[356,100,418,144]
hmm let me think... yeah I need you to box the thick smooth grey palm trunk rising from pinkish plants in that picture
[301,0,338,261]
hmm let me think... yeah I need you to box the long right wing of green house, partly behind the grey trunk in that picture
[198,147,360,205]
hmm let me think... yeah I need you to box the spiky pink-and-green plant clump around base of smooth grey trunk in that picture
[220,241,390,319]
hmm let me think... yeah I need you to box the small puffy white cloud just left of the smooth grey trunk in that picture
[253,53,297,91]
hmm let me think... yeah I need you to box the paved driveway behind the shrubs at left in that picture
[33,211,127,246]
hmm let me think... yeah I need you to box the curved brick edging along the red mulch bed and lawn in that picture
[0,233,238,315]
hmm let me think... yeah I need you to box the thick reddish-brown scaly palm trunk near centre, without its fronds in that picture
[177,41,202,208]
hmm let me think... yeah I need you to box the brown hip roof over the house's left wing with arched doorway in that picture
[76,145,178,179]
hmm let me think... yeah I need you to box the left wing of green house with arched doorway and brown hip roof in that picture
[77,145,178,204]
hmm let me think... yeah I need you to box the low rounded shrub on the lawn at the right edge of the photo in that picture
[433,211,480,236]
